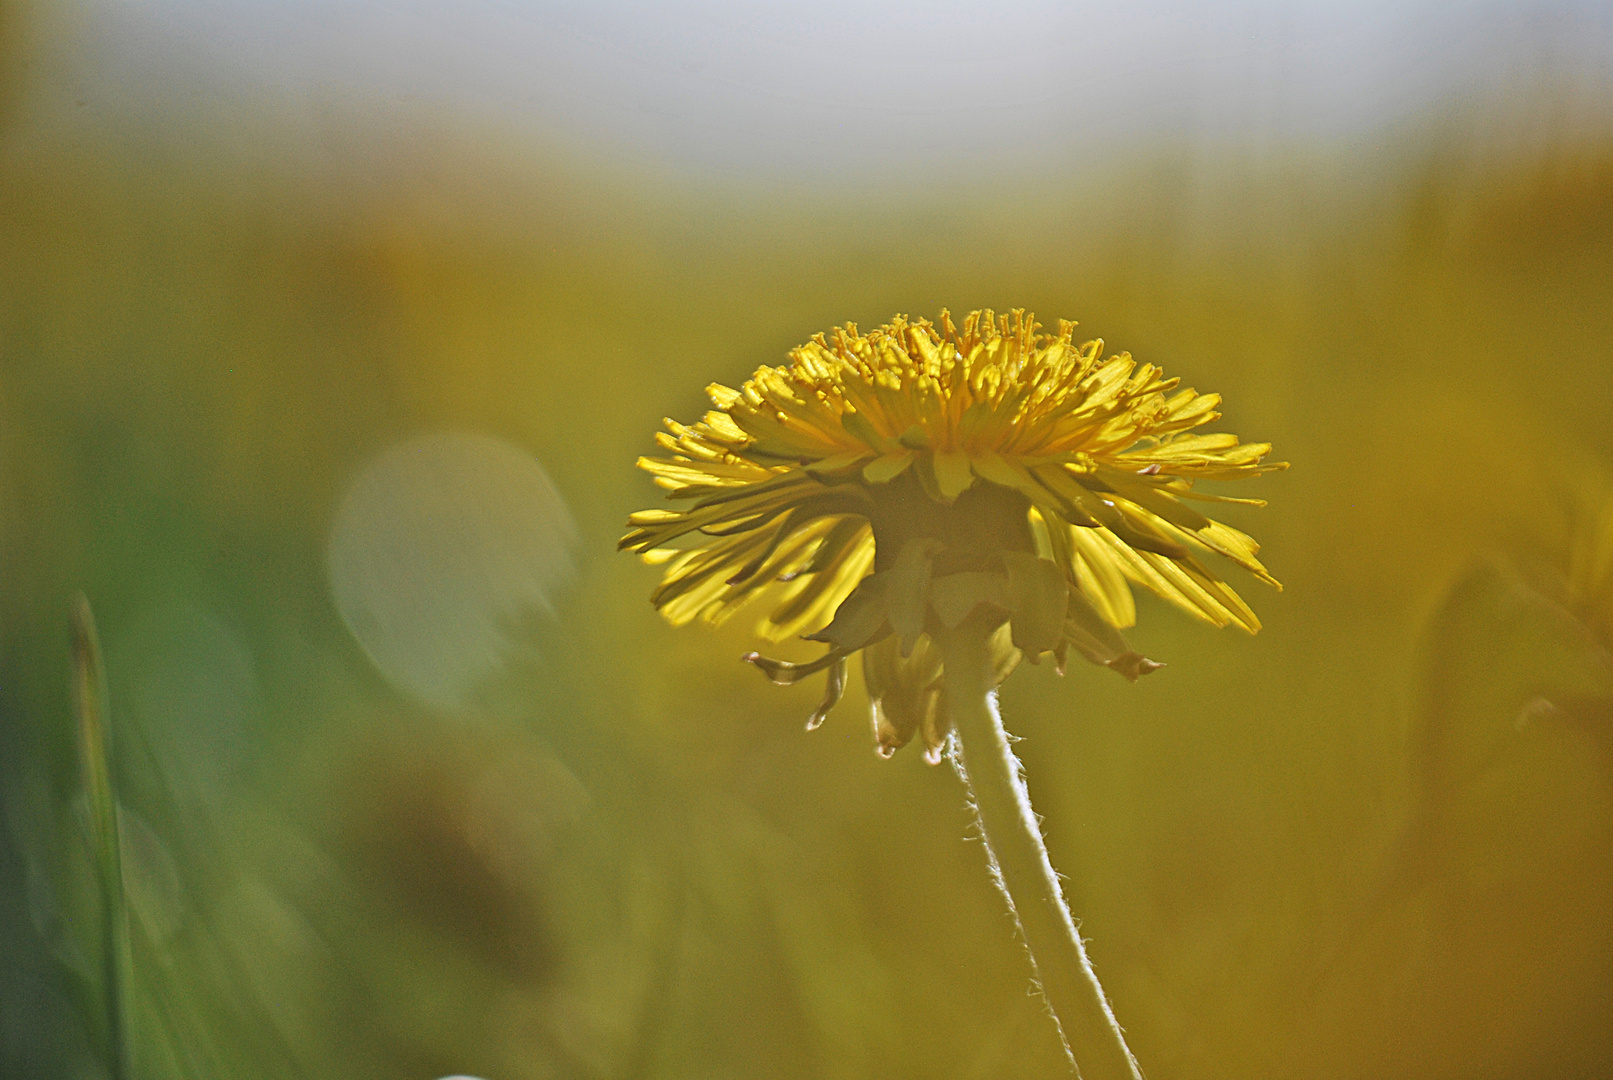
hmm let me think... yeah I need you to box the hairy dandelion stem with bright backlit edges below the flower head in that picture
[939,613,1142,1080]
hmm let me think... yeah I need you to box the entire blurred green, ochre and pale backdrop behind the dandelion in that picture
[0,0,1613,1080]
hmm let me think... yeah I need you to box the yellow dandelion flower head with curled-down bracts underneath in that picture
[621,311,1286,759]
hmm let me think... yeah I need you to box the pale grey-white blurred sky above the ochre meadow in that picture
[56,0,1613,177]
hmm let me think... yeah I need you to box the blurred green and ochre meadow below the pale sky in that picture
[0,5,1613,1080]
